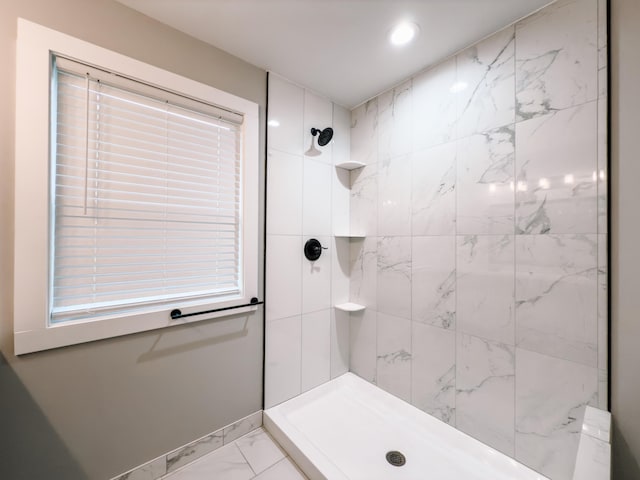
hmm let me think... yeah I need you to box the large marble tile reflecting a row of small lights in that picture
[516,102,597,233]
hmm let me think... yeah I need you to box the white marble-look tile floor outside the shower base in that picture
[162,428,307,480]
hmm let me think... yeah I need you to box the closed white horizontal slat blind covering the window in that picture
[49,57,243,323]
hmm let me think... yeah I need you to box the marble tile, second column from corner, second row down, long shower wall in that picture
[378,156,411,236]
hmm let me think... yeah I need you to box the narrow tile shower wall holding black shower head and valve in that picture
[265,74,351,408]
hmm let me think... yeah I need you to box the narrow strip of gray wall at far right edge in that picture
[610,0,640,480]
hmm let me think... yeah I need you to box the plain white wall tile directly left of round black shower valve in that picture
[265,235,303,320]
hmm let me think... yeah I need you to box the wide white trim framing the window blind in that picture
[14,18,259,355]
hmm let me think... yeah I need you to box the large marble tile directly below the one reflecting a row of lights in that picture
[516,235,598,367]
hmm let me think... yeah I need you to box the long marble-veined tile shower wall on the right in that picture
[350,0,607,480]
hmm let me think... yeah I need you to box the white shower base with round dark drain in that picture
[264,373,548,480]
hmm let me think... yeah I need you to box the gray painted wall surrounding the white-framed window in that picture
[0,0,266,480]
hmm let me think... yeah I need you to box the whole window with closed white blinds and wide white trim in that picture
[14,19,258,354]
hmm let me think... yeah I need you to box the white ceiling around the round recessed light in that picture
[118,0,551,108]
